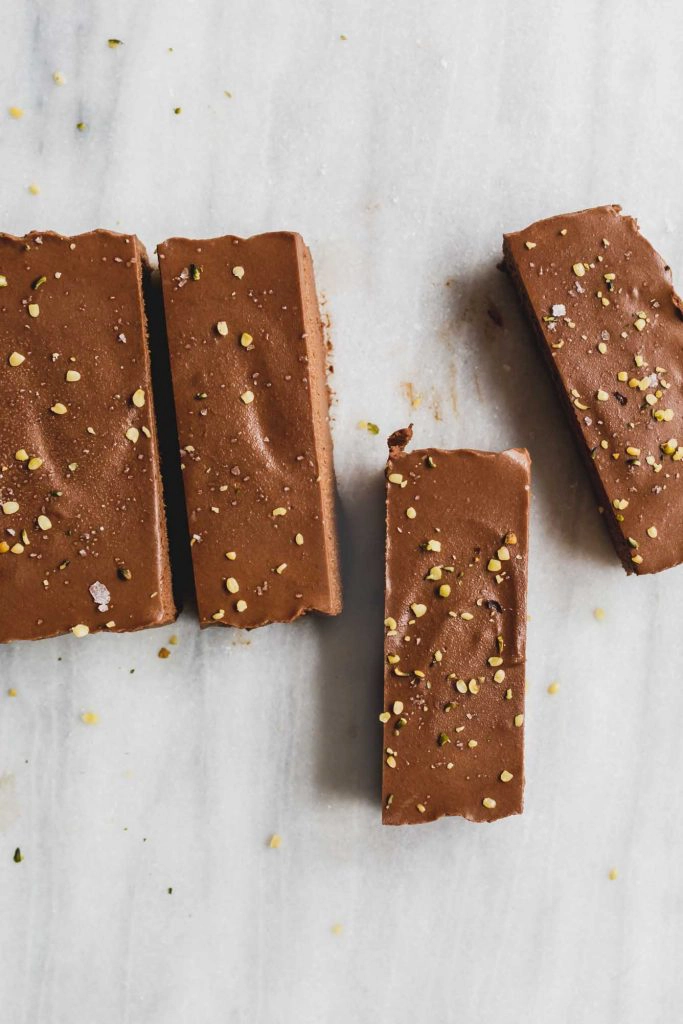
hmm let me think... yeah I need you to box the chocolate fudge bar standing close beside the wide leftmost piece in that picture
[159,231,341,629]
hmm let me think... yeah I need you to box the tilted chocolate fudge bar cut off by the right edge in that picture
[503,206,683,574]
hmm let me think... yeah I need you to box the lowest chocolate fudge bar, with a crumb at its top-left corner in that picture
[380,428,530,825]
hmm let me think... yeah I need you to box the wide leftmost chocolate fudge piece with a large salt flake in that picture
[0,231,175,642]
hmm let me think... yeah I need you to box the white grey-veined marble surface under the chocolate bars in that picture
[0,0,683,1024]
